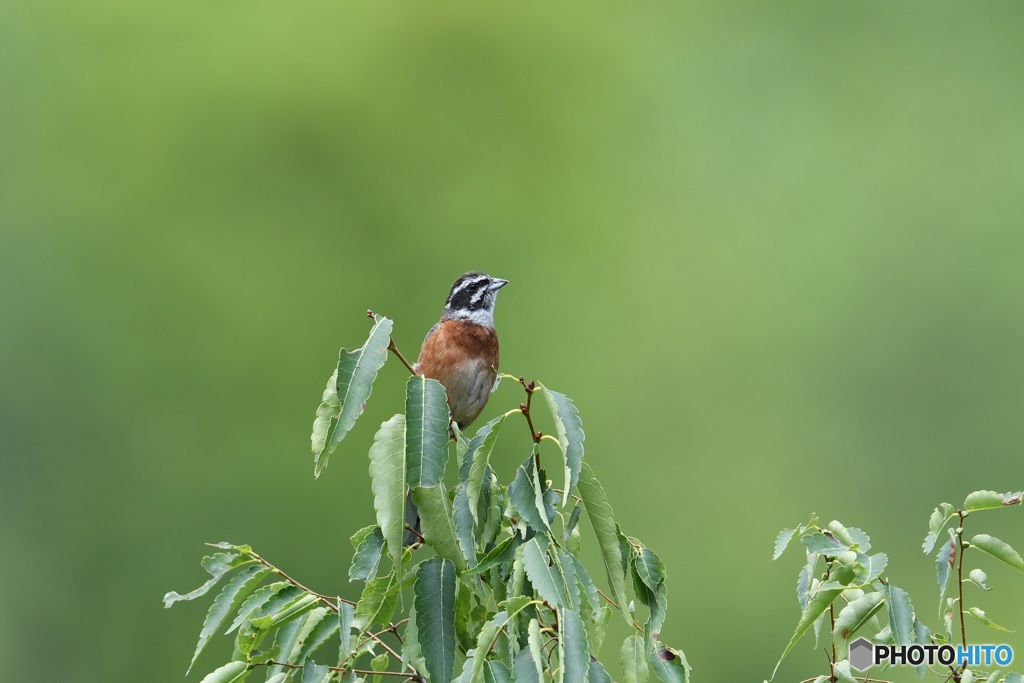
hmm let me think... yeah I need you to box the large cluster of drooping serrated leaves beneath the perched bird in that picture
[165,311,689,683]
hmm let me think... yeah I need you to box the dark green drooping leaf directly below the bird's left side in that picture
[406,375,449,487]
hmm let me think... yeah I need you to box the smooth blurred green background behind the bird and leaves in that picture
[0,0,1024,682]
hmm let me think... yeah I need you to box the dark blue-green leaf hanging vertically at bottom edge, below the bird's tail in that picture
[415,557,458,681]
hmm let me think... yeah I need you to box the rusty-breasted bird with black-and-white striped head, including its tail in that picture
[404,270,508,546]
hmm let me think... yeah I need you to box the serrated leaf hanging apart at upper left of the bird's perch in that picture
[310,315,393,477]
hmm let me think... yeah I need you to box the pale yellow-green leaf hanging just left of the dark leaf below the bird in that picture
[370,413,406,571]
